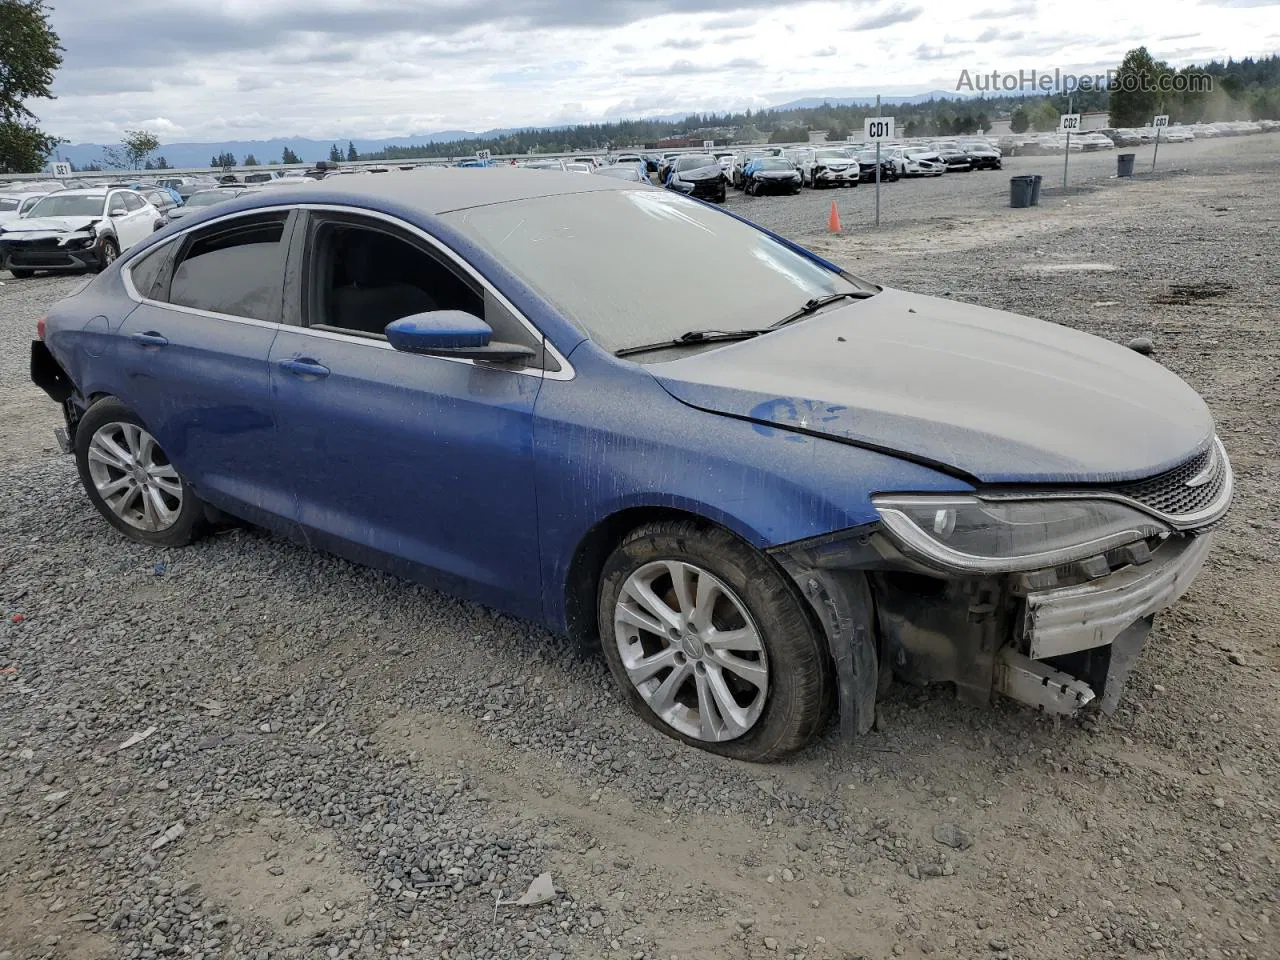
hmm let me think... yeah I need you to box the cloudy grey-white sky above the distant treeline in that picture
[40,0,1280,142]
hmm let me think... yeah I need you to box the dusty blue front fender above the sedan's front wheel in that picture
[534,344,972,630]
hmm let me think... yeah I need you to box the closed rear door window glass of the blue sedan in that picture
[169,212,288,323]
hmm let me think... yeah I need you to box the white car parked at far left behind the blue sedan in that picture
[0,187,164,279]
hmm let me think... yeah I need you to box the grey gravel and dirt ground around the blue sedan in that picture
[0,136,1280,960]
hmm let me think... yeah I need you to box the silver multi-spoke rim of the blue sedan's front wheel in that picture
[613,561,769,742]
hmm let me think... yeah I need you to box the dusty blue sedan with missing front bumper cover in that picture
[32,169,1233,760]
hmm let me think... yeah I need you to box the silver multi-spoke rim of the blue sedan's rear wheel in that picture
[88,422,182,534]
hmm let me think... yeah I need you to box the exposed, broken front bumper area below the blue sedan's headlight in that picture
[772,524,1213,735]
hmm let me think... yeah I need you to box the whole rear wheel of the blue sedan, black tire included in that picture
[76,397,205,547]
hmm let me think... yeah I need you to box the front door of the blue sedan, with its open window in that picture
[270,214,541,617]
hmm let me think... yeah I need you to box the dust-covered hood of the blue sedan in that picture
[649,289,1213,484]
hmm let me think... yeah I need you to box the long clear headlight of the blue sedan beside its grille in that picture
[872,497,1171,573]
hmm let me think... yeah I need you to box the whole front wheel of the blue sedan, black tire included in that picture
[596,521,836,763]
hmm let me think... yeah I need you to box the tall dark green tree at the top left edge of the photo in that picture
[0,0,63,173]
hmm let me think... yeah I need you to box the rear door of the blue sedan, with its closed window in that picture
[115,210,294,527]
